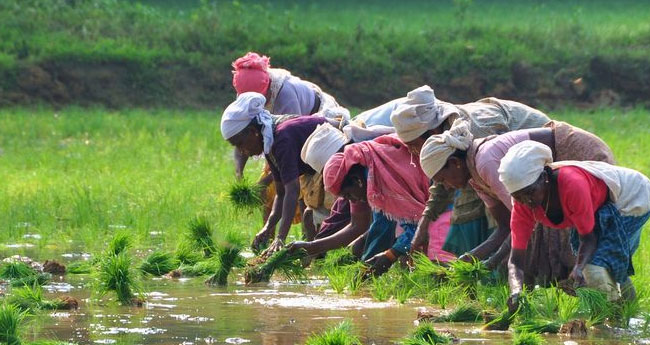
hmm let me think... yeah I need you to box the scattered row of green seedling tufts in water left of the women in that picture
[0,202,312,345]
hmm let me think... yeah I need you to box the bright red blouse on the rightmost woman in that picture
[510,166,608,249]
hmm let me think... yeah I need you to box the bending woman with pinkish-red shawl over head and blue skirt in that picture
[323,135,453,274]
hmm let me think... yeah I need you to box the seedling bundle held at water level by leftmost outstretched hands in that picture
[244,248,307,285]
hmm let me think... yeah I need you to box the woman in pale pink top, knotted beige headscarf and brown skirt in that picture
[420,120,614,284]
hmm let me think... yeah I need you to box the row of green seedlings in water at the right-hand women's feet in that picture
[313,245,650,344]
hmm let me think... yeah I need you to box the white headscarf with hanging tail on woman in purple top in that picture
[221,92,273,154]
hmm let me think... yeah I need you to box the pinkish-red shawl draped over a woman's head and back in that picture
[323,134,429,222]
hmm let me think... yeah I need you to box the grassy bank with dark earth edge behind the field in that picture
[0,0,650,108]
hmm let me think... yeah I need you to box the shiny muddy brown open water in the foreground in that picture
[2,249,644,345]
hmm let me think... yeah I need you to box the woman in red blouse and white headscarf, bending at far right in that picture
[499,140,650,309]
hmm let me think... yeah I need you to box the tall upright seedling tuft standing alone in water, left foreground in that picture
[97,252,139,305]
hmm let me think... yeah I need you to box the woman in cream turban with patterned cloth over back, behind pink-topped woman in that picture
[391,85,550,259]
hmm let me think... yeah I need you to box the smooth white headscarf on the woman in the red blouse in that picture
[498,140,553,194]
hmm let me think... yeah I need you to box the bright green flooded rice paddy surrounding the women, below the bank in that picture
[0,107,650,344]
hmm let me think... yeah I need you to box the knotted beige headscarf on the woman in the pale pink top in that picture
[420,119,474,178]
